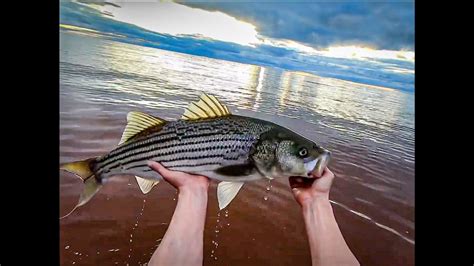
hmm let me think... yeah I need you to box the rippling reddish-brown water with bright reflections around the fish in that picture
[58,31,415,265]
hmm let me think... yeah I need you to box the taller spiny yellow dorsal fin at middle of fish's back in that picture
[181,93,231,120]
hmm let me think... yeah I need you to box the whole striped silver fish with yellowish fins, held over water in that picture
[60,93,331,218]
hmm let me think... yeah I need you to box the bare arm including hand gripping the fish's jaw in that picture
[290,168,359,266]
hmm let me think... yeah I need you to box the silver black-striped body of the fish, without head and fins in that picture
[92,115,277,181]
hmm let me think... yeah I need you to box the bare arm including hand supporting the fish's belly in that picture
[148,162,209,265]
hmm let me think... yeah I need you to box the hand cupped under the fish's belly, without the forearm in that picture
[147,161,209,192]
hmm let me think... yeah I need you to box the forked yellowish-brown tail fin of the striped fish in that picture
[59,158,102,219]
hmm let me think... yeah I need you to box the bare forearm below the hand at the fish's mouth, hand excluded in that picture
[302,197,359,266]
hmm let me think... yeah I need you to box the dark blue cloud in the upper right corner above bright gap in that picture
[179,1,414,50]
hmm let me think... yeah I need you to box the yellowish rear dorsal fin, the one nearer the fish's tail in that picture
[119,112,166,145]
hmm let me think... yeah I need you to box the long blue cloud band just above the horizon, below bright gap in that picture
[60,2,414,91]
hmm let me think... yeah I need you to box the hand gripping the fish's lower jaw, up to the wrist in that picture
[289,167,334,206]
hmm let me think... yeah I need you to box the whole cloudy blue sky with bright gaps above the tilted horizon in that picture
[60,0,414,92]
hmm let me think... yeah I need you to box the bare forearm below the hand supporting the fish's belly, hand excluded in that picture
[149,189,207,265]
